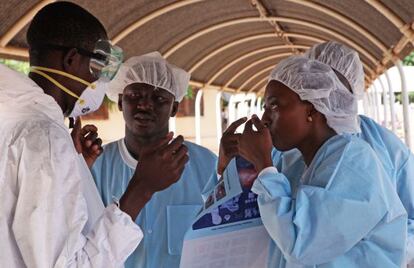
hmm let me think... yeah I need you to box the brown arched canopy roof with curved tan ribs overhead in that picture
[0,0,414,147]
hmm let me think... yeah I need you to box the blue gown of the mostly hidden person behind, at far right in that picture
[272,115,414,262]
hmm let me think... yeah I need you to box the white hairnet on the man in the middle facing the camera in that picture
[106,52,190,102]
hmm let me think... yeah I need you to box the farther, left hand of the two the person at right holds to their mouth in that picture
[217,117,247,175]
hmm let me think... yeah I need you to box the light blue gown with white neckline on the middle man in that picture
[92,139,217,268]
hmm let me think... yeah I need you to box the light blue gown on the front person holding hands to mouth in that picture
[258,135,407,268]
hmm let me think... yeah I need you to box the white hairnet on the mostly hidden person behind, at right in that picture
[304,41,365,99]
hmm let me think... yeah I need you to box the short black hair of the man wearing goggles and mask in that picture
[26,2,107,61]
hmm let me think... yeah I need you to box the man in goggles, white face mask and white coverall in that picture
[0,2,188,267]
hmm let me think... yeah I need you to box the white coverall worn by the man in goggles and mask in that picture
[0,65,143,268]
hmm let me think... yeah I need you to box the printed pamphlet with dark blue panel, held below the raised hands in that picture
[180,157,270,268]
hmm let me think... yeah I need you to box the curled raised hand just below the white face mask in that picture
[71,117,103,168]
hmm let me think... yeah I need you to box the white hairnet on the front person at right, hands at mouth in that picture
[269,56,360,134]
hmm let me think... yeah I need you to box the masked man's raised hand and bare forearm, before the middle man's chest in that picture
[120,132,189,219]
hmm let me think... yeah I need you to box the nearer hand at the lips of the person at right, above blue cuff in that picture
[239,115,273,173]
